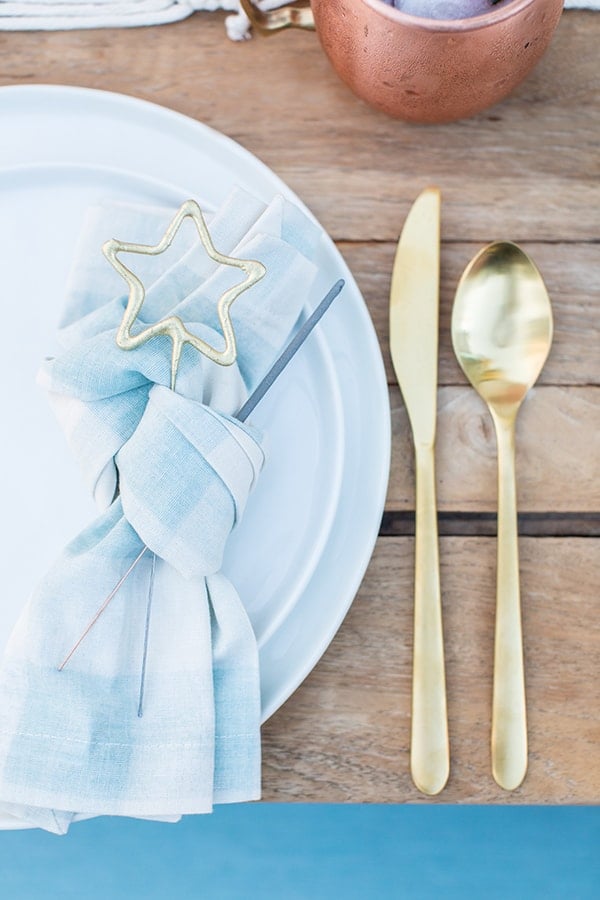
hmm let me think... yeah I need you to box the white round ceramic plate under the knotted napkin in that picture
[0,86,390,732]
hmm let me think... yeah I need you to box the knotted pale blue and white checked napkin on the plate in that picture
[0,191,321,832]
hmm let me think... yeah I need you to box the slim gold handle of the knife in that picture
[410,445,450,795]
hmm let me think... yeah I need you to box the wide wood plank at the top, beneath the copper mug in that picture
[0,13,600,242]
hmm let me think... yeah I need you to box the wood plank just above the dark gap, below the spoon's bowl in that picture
[386,387,600,513]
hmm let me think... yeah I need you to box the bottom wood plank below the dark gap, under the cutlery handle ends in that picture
[263,538,600,803]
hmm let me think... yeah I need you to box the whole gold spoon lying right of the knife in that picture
[452,241,552,791]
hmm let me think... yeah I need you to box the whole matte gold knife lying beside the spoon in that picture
[390,188,450,795]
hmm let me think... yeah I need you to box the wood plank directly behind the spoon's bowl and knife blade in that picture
[339,241,600,385]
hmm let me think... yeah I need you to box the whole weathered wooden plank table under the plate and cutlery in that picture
[0,12,600,803]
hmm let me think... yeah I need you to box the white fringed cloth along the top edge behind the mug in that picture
[0,0,600,40]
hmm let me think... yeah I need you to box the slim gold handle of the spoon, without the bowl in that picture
[492,414,527,791]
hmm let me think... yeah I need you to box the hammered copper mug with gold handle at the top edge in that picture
[241,0,563,122]
